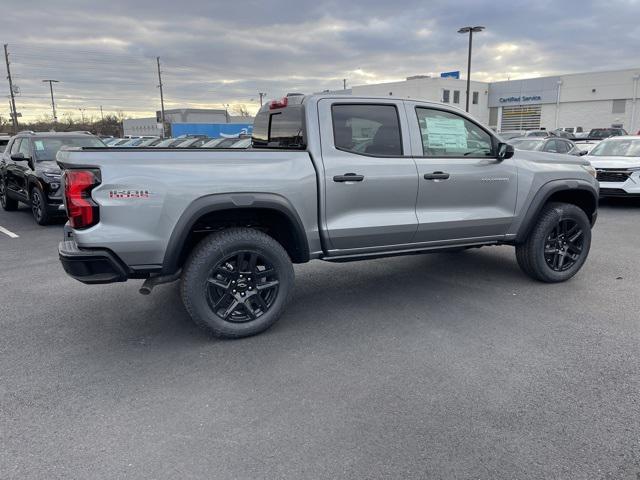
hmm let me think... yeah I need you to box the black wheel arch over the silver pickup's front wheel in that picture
[515,180,598,243]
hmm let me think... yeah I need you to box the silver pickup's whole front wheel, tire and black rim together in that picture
[516,202,591,283]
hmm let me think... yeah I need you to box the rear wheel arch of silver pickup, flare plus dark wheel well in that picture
[162,193,309,274]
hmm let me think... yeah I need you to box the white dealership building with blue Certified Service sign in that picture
[351,68,640,133]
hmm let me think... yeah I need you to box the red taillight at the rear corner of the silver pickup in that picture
[64,170,100,228]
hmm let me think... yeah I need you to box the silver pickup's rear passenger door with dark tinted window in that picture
[318,99,418,253]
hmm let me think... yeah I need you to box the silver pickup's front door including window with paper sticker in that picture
[407,105,517,242]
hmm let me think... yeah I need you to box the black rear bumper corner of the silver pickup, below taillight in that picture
[58,239,128,284]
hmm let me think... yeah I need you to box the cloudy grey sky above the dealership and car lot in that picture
[0,0,640,120]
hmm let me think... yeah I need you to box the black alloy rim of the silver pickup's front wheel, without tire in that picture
[544,219,584,272]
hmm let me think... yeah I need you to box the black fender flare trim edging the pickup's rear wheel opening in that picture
[162,193,309,274]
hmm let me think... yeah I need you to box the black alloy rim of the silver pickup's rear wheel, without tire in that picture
[206,250,280,323]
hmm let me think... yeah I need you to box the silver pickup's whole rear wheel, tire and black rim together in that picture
[181,228,294,338]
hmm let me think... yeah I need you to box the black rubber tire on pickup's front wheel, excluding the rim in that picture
[516,202,591,283]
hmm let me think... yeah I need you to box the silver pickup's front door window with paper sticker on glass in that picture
[416,108,493,158]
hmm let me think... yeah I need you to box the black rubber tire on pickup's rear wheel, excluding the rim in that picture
[181,228,294,339]
